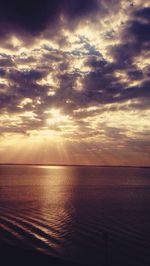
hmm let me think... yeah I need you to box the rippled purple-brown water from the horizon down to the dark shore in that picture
[0,166,150,266]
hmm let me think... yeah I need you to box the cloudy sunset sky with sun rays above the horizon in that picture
[0,0,150,166]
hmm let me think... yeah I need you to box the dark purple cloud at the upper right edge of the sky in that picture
[110,8,150,65]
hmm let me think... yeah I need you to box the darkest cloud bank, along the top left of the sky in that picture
[0,0,98,36]
